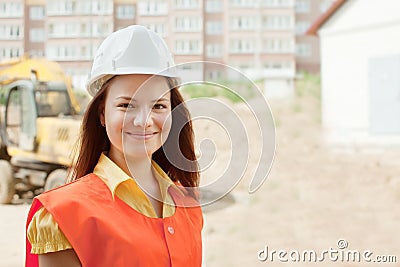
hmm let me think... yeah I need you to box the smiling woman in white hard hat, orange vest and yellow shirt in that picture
[26,25,203,267]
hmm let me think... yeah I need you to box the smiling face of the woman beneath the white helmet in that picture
[100,74,172,164]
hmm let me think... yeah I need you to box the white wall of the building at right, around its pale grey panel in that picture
[319,0,400,144]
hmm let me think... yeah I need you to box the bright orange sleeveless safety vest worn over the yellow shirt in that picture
[26,174,203,267]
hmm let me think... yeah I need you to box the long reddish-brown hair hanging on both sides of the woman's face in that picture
[69,78,199,196]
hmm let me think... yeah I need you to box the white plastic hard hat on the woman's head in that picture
[86,25,178,96]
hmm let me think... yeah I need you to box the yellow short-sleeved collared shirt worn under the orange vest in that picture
[27,154,175,254]
